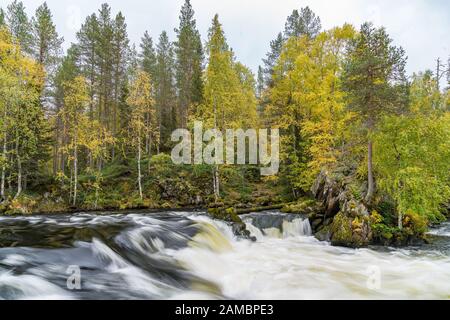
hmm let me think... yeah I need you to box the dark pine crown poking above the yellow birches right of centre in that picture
[284,7,322,39]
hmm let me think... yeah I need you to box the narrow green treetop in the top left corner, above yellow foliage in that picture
[6,0,33,54]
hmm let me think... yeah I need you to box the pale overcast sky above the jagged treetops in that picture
[0,0,450,74]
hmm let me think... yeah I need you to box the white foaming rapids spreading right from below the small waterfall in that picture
[173,214,450,299]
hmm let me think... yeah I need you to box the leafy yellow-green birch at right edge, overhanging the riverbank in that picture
[374,112,450,229]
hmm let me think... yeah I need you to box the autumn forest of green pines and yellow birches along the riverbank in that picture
[0,0,450,247]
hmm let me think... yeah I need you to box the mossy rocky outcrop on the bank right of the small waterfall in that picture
[309,171,372,248]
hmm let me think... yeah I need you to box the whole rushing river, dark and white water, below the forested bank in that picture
[0,212,450,299]
